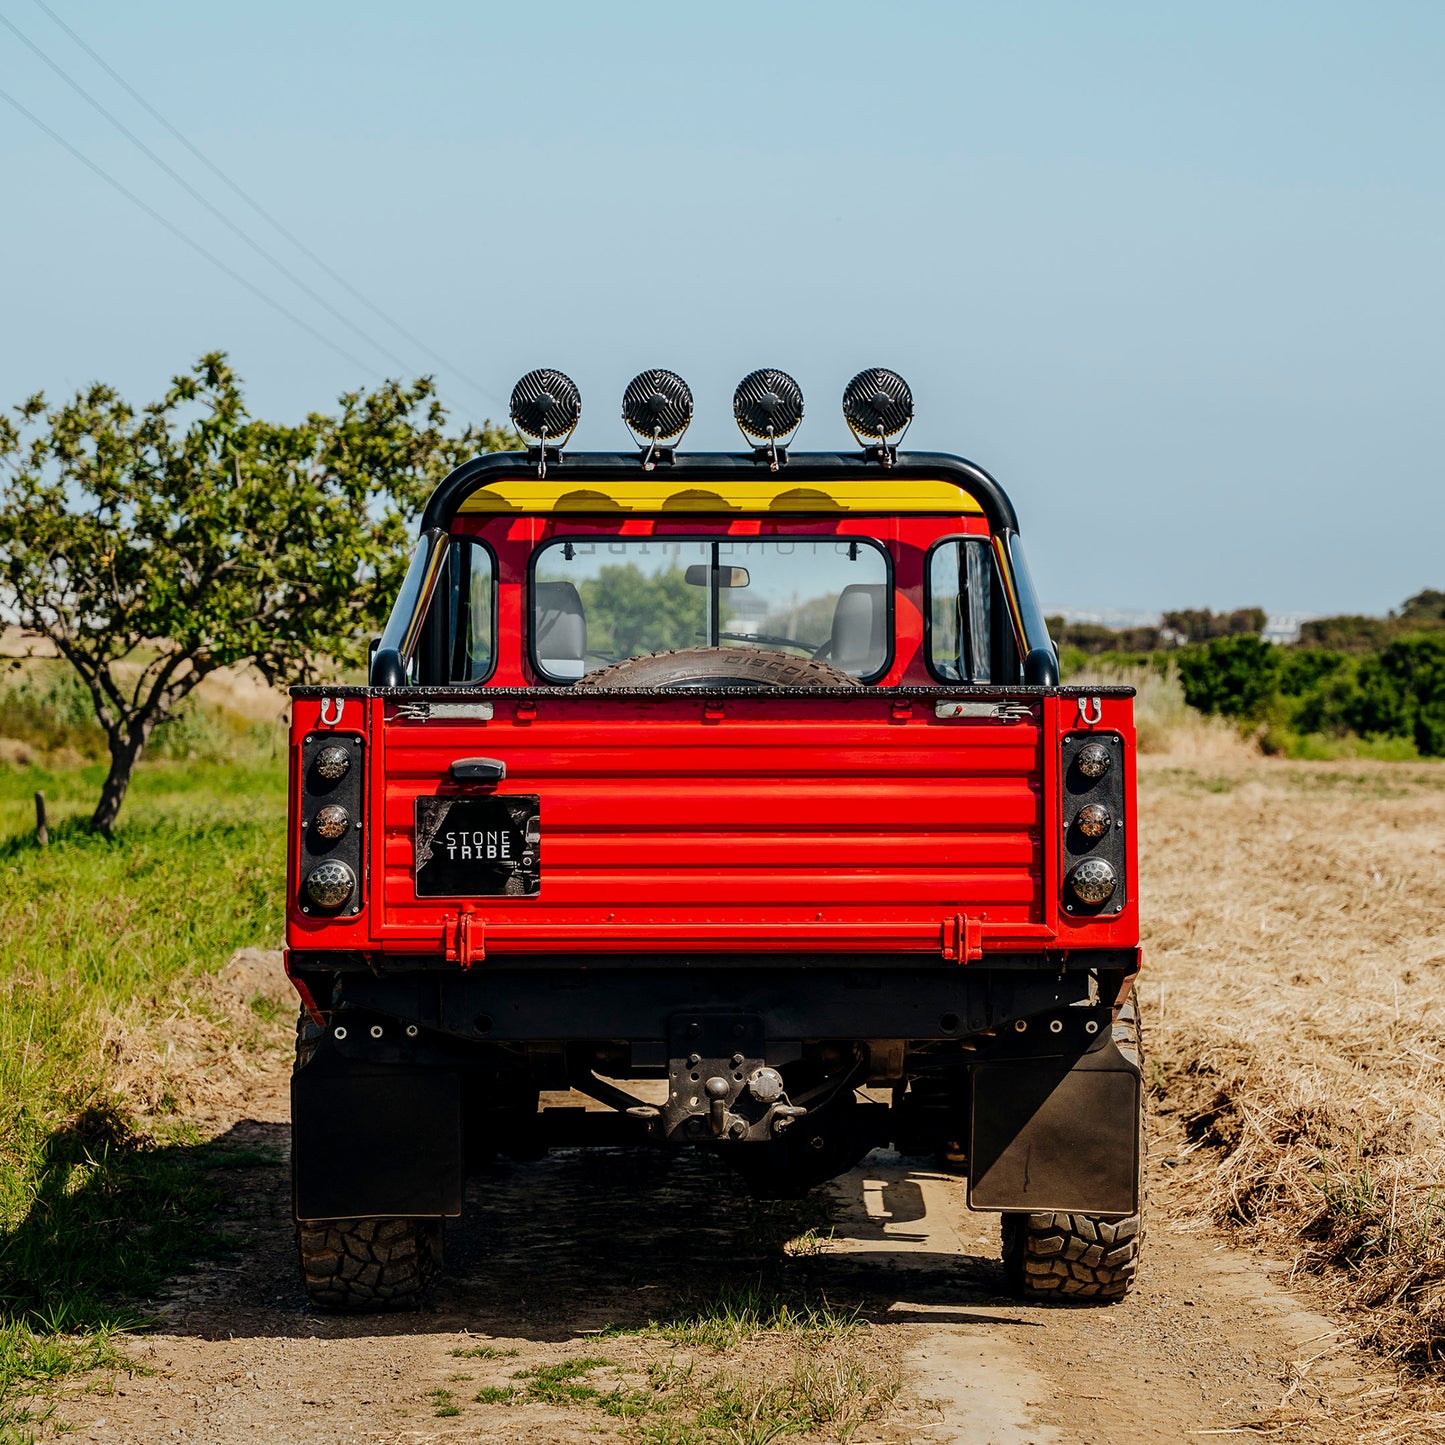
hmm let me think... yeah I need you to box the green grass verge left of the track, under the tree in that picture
[0,762,285,1438]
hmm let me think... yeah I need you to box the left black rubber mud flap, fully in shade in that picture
[290,1065,462,1220]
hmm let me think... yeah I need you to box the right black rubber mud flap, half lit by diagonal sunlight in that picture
[968,1040,1143,1215]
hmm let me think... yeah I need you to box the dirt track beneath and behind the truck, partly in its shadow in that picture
[50,1062,1389,1445]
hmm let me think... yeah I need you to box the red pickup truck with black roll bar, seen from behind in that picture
[288,369,1143,1309]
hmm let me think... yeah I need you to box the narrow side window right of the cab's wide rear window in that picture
[928,538,1020,685]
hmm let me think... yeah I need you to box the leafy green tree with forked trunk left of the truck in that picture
[0,353,510,834]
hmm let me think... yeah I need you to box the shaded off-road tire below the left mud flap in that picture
[296,1220,441,1312]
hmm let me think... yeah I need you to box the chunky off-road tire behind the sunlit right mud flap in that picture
[1003,997,1144,1302]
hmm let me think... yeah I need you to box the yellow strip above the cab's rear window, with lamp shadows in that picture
[457,470,983,516]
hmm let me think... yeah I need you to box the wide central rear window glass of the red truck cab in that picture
[532,538,892,682]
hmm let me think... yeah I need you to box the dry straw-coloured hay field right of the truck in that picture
[1140,745,1445,1364]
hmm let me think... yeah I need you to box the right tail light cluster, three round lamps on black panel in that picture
[1062,733,1127,916]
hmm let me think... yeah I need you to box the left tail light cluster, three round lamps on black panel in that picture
[296,733,366,918]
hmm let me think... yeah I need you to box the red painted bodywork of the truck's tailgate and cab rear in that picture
[288,513,1139,967]
